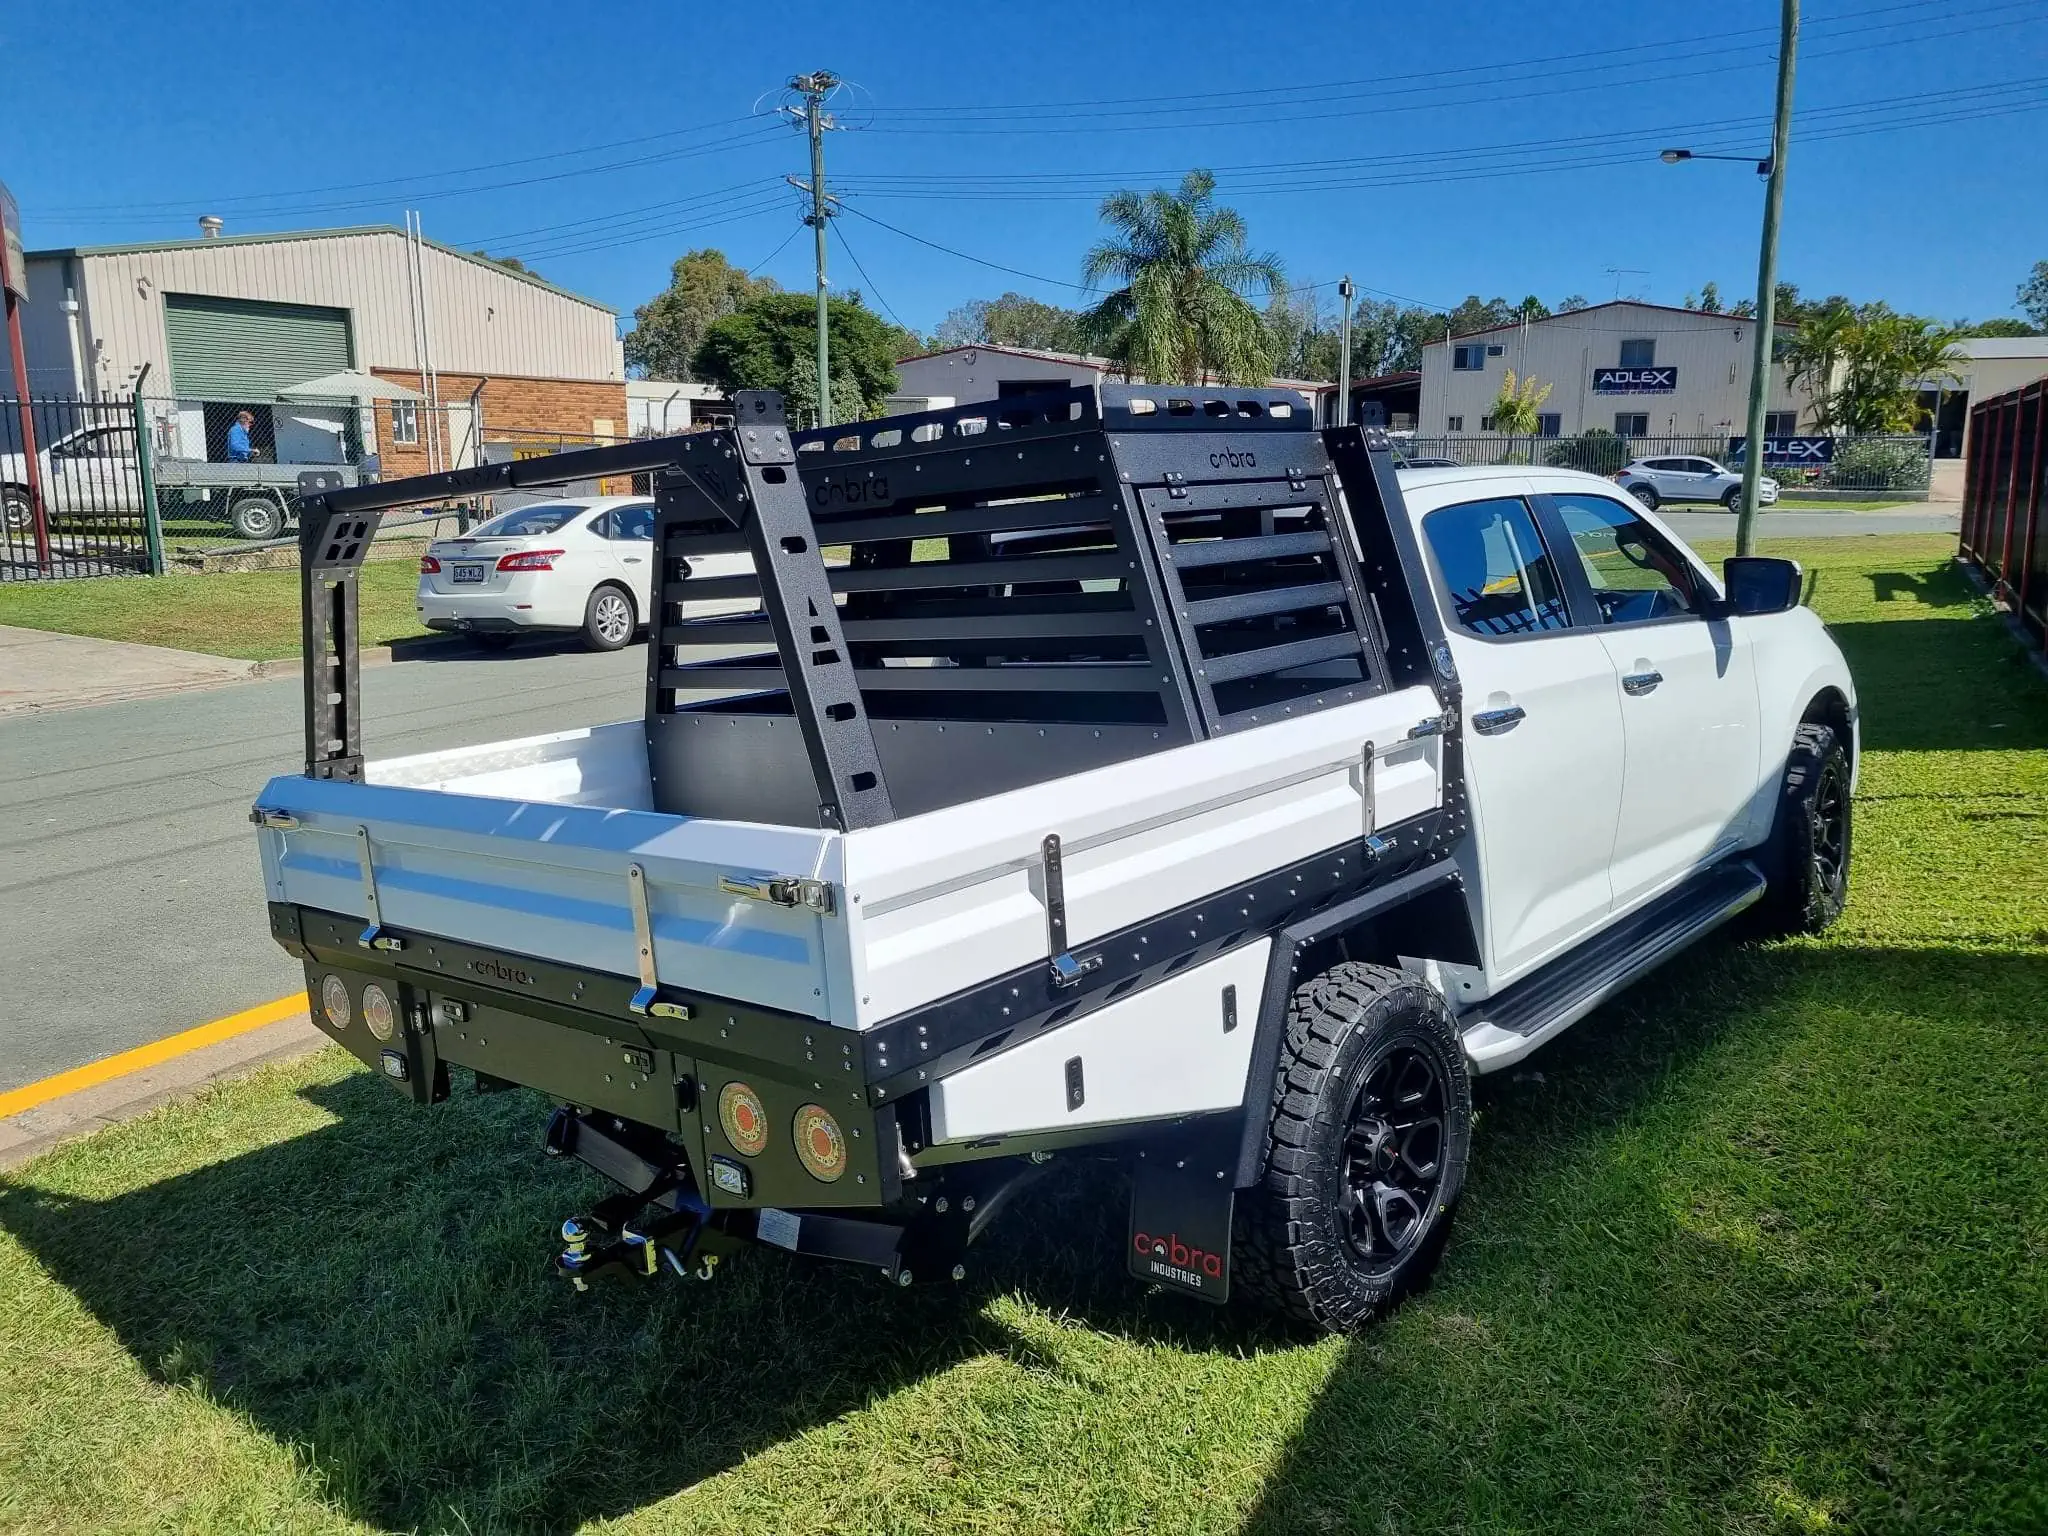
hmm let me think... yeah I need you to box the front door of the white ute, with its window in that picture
[1538,489,1759,911]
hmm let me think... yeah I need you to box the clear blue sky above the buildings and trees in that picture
[0,0,2048,330]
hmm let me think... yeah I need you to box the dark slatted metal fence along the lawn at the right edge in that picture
[1962,379,2048,649]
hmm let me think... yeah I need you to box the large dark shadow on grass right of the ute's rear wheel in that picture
[1245,944,2048,1536]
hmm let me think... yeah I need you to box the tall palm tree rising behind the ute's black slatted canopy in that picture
[1081,170,1286,383]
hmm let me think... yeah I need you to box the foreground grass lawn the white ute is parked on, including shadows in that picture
[0,539,2048,1536]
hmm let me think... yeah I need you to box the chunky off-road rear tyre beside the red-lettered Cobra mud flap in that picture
[1231,961,1473,1333]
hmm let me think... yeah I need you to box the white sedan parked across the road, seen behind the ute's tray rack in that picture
[418,496,752,651]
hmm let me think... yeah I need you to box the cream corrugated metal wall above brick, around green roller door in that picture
[75,229,625,389]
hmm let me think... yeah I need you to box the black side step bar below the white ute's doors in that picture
[1460,860,1763,1071]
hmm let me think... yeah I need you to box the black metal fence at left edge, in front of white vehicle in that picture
[0,397,162,582]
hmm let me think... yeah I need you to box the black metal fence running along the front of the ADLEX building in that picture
[1399,428,1931,502]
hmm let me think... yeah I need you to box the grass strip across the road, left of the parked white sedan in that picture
[0,559,428,662]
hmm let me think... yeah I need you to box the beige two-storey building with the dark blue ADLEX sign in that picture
[1415,299,1812,438]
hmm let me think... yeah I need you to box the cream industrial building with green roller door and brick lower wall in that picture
[0,221,627,475]
